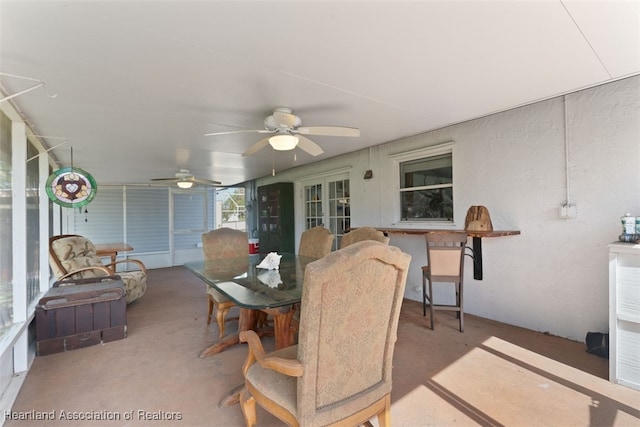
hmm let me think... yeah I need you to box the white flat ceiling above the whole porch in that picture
[0,0,640,185]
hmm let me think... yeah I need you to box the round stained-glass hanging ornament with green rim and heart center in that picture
[45,148,98,208]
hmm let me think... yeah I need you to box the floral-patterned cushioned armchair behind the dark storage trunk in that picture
[49,234,147,304]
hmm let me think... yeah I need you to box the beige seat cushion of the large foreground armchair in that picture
[245,345,298,414]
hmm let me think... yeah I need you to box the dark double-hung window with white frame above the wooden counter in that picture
[399,149,453,222]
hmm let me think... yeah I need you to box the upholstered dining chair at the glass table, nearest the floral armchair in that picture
[202,227,249,338]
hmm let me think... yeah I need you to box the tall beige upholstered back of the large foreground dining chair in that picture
[297,241,411,425]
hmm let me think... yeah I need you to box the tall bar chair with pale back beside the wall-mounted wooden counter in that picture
[422,231,467,332]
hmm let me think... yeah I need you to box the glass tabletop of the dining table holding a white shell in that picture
[184,254,315,309]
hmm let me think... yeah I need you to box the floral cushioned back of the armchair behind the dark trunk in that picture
[49,234,106,279]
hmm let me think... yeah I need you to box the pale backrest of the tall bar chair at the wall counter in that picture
[425,232,467,283]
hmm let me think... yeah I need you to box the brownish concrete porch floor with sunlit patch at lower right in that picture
[4,267,640,427]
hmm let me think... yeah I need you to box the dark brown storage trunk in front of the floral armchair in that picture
[36,276,127,356]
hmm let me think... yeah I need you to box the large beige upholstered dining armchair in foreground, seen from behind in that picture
[240,241,411,426]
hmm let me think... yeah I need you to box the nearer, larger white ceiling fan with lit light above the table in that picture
[205,107,360,156]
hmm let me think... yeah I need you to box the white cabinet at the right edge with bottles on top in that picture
[609,242,640,390]
